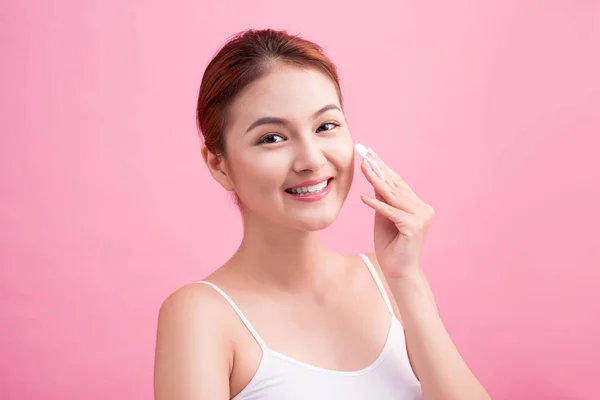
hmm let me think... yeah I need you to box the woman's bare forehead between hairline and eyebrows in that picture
[230,66,341,127]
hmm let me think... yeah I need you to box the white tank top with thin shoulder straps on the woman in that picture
[198,254,423,400]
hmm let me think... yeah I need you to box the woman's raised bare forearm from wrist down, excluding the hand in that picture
[387,273,490,400]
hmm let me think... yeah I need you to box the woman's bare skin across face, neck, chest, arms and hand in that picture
[154,63,489,400]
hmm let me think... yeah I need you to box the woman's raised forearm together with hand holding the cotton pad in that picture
[361,150,490,400]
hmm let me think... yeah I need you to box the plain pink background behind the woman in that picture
[0,0,600,400]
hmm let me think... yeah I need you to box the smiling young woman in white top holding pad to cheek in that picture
[155,30,489,400]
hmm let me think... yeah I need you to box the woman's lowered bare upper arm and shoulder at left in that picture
[154,285,233,400]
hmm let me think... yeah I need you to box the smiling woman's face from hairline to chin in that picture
[218,65,354,231]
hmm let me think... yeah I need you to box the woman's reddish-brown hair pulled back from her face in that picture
[196,29,343,156]
